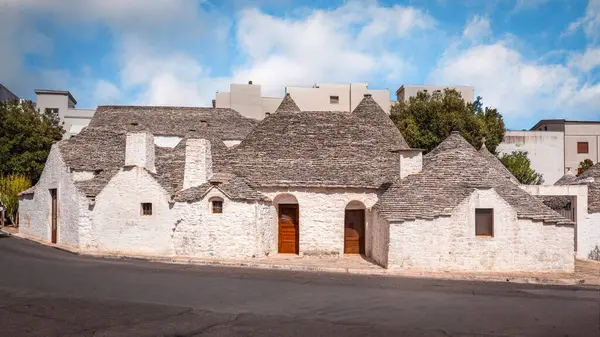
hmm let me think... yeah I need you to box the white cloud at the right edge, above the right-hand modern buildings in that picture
[429,15,600,122]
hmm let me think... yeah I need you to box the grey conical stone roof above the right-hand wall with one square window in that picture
[377,132,573,225]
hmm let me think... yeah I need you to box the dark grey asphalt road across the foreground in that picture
[0,238,600,337]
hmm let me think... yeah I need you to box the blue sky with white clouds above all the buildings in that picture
[0,0,600,129]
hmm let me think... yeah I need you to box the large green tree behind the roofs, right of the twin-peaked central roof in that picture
[391,89,505,153]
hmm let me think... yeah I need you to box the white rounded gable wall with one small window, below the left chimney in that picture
[82,167,175,255]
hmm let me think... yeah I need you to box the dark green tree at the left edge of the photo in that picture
[0,101,64,183]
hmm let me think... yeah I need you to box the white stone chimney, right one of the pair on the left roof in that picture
[183,139,212,189]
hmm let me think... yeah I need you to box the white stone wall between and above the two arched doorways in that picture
[260,188,378,255]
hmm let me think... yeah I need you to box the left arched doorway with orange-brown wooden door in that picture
[273,194,300,254]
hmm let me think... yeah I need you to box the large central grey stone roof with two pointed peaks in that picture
[231,95,408,188]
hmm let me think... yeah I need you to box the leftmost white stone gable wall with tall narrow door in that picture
[19,144,85,247]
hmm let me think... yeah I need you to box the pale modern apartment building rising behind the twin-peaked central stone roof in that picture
[213,81,394,120]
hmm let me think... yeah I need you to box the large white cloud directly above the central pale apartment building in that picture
[233,1,435,95]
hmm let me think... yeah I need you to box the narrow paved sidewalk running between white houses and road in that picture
[5,230,600,286]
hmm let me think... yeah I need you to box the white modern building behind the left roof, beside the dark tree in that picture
[35,89,96,139]
